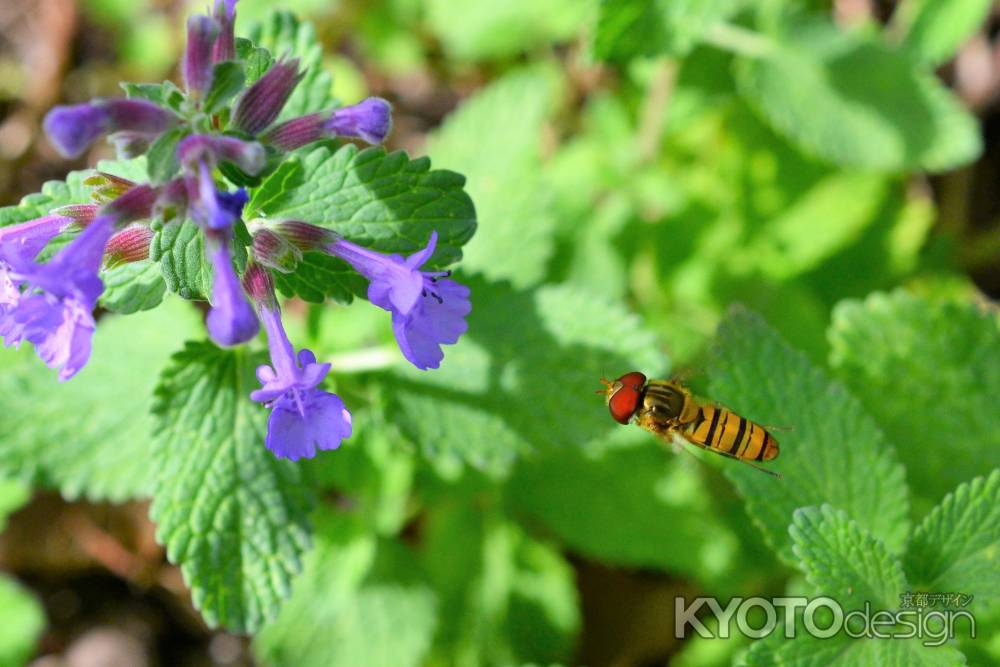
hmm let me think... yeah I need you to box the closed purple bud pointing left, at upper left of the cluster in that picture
[43,99,177,157]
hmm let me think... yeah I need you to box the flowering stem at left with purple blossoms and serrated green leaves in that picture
[0,0,475,629]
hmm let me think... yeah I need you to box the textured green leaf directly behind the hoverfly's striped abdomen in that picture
[706,310,909,564]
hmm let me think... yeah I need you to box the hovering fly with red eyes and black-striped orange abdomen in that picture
[597,371,781,478]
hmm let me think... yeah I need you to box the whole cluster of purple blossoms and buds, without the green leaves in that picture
[0,0,471,460]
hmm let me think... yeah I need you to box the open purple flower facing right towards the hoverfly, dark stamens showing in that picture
[326,232,472,370]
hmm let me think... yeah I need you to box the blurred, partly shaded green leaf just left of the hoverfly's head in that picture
[388,278,666,476]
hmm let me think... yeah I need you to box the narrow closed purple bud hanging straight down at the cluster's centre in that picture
[205,230,260,347]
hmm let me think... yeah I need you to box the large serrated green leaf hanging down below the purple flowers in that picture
[150,343,312,633]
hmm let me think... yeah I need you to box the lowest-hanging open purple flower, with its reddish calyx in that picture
[244,265,351,461]
